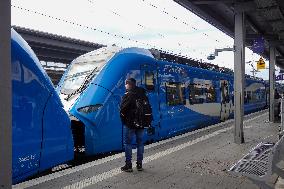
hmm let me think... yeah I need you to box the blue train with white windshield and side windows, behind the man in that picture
[57,46,266,155]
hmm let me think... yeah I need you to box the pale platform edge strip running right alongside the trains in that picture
[13,110,268,189]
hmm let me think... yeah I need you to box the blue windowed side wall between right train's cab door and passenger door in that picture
[156,61,223,138]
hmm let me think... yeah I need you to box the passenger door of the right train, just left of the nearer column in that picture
[220,80,231,121]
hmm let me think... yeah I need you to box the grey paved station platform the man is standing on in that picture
[13,110,284,189]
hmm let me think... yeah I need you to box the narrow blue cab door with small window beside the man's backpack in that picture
[141,64,160,140]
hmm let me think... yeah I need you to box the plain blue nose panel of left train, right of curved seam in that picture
[40,93,74,171]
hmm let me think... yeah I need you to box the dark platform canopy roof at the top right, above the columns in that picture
[175,0,284,69]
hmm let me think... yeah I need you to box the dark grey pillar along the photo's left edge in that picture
[0,0,12,189]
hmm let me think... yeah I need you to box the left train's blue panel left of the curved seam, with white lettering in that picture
[11,28,50,182]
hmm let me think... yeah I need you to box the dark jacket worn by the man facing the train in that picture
[120,87,146,128]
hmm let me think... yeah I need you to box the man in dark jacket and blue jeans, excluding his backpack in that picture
[120,78,147,172]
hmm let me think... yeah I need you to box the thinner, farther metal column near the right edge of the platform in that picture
[269,46,275,122]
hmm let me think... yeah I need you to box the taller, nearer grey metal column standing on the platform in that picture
[234,12,246,144]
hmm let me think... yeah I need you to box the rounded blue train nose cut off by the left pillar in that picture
[11,29,74,183]
